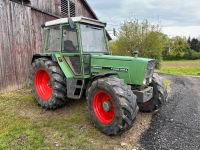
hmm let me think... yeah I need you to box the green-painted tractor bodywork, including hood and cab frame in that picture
[41,17,155,85]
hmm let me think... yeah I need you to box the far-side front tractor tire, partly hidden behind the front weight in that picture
[138,73,167,112]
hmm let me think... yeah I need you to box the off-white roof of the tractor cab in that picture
[45,17,106,27]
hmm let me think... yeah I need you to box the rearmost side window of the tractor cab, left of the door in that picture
[48,26,60,51]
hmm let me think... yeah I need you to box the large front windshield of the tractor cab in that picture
[81,25,108,52]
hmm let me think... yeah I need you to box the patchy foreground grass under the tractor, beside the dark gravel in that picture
[0,90,151,150]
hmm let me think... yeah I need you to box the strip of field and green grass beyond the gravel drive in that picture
[159,60,200,75]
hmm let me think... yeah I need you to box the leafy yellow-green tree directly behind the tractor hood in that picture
[110,19,166,67]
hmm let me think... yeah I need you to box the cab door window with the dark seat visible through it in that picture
[62,26,78,53]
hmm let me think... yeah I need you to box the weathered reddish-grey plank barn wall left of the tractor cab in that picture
[0,0,55,91]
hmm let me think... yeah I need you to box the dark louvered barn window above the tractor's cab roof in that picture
[61,0,76,17]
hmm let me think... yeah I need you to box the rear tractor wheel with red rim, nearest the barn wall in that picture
[30,58,67,109]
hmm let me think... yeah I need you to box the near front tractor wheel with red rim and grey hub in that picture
[87,77,139,135]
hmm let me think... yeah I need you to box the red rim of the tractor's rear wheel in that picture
[34,69,52,101]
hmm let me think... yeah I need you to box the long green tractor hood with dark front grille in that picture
[91,55,155,85]
